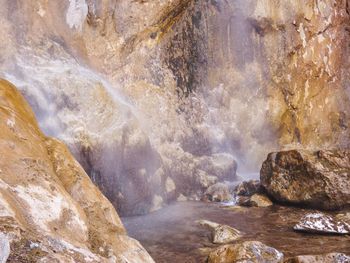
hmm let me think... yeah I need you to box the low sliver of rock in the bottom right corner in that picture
[286,253,350,263]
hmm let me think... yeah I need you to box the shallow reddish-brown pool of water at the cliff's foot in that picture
[122,202,350,263]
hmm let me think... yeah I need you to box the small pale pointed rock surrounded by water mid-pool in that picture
[197,220,241,244]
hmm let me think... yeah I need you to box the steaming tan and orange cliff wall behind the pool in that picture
[0,0,349,214]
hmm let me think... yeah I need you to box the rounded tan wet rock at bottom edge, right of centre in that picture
[208,241,283,263]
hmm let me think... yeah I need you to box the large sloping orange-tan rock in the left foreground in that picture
[0,80,153,262]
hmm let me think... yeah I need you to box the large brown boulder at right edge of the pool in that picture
[260,150,350,209]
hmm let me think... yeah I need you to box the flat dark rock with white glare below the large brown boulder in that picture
[294,213,350,234]
